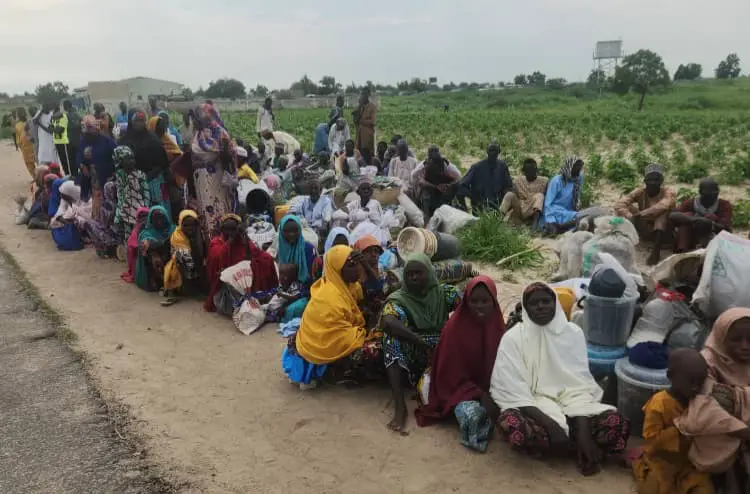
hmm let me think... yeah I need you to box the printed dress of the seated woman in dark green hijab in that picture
[381,285,461,385]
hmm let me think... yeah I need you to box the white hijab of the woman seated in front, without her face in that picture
[490,283,613,433]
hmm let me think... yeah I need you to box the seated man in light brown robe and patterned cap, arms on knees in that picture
[615,164,675,266]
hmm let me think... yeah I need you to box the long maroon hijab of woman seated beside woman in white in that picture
[415,275,505,426]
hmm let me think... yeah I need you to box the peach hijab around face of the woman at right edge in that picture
[701,307,750,386]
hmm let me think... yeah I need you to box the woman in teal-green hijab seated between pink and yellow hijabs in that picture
[135,206,174,292]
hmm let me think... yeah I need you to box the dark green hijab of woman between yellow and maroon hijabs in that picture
[388,254,449,332]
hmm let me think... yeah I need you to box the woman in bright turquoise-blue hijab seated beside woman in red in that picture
[276,214,317,322]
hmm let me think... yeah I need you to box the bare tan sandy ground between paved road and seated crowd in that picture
[0,144,632,494]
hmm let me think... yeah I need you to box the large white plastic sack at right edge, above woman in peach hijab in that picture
[693,231,750,319]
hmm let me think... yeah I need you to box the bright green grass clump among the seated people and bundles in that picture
[456,211,544,269]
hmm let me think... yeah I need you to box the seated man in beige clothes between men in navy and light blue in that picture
[500,158,549,226]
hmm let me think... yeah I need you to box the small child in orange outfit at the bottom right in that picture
[633,348,715,494]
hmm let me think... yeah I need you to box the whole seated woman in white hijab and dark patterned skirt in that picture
[490,283,629,475]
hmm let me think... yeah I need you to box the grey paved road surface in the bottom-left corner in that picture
[0,258,164,494]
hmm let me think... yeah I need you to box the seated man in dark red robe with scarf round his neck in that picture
[669,177,732,253]
